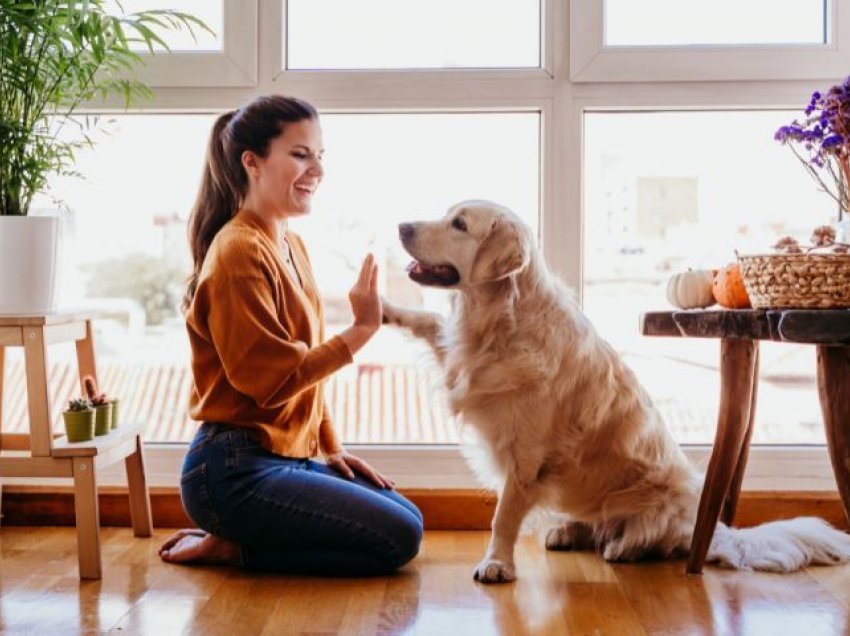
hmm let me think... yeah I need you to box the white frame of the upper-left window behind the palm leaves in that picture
[132,0,259,88]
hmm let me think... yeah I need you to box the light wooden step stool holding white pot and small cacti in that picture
[0,313,153,579]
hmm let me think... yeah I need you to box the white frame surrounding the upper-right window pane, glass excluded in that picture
[570,0,850,82]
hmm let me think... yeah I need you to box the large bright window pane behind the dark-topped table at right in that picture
[584,111,835,443]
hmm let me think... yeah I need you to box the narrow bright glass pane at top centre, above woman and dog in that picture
[286,0,540,69]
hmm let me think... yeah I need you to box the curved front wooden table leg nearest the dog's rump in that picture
[687,338,757,574]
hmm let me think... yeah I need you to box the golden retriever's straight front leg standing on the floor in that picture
[474,474,536,583]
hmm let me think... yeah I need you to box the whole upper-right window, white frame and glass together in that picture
[569,0,850,82]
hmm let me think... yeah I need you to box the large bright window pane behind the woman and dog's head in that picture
[18,113,539,443]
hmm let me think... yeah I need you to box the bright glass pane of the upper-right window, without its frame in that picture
[605,0,827,46]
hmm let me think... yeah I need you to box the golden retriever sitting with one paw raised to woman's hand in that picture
[384,201,850,583]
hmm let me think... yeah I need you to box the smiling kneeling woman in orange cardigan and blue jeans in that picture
[160,95,422,575]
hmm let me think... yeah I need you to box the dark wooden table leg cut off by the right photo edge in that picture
[817,345,850,520]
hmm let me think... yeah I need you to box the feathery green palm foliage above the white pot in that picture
[0,0,209,216]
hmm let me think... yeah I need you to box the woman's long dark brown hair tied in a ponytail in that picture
[183,95,319,311]
